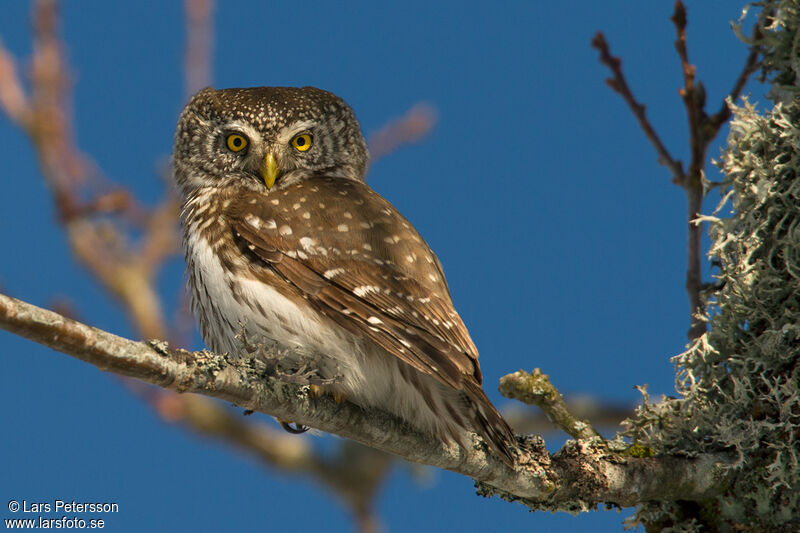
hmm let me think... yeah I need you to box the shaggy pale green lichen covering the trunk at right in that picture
[628,4,800,532]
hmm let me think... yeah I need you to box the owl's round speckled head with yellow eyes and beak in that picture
[173,87,368,196]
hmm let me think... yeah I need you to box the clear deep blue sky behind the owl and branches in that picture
[0,0,762,532]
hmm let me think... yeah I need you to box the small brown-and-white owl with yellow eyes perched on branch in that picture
[173,87,514,464]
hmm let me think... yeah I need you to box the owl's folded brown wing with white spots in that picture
[226,179,481,389]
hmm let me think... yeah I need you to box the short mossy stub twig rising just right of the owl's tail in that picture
[500,368,602,439]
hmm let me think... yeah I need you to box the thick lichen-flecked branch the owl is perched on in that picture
[0,294,732,511]
